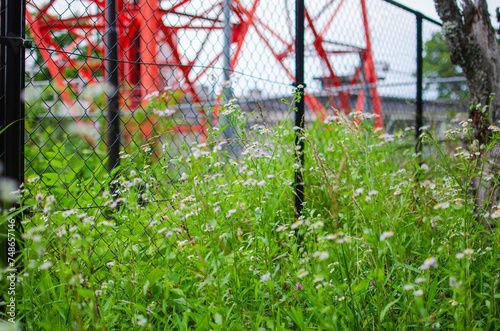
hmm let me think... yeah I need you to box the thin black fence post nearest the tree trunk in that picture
[415,13,424,153]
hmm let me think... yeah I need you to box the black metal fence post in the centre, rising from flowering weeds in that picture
[295,0,305,216]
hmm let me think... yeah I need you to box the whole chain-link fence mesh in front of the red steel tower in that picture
[19,0,463,208]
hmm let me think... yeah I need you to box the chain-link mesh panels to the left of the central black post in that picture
[25,1,302,208]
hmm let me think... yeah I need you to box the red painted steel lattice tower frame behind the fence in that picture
[26,0,383,131]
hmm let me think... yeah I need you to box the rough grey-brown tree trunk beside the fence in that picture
[434,0,500,226]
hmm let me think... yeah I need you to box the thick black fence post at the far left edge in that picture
[0,0,25,320]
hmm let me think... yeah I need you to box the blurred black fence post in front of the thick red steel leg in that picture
[106,0,120,172]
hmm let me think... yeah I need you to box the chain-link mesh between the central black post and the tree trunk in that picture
[306,1,468,133]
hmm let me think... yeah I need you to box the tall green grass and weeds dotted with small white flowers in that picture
[2,94,500,330]
